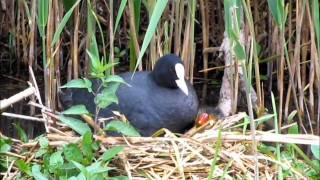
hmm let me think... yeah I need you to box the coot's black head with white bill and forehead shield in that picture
[151,54,188,95]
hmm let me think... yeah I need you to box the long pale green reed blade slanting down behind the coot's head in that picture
[135,0,168,70]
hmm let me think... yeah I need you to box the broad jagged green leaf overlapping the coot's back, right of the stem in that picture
[94,84,119,108]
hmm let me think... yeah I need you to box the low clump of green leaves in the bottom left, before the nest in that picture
[11,132,127,180]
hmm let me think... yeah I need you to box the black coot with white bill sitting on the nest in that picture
[60,54,199,136]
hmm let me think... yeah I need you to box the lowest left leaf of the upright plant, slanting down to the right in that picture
[59,115,91,135]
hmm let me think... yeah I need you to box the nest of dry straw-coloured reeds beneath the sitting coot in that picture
[0,74,320,179]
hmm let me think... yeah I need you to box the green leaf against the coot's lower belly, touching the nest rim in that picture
[104,120,140,137]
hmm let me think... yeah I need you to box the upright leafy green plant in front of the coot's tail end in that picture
[59,29,139,136]
